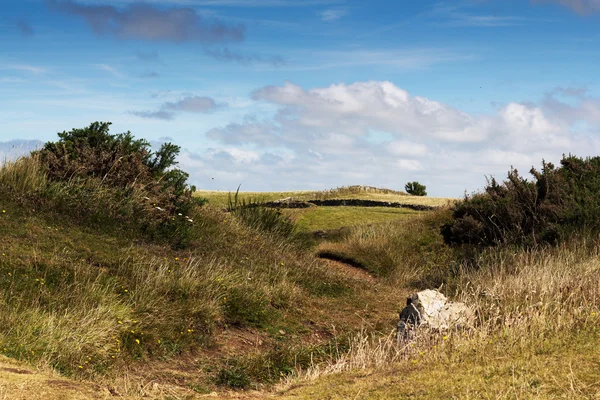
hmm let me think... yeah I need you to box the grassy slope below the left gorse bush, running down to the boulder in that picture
[0,196,406,392]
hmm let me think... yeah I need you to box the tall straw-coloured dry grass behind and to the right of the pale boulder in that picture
[287,241,600,385]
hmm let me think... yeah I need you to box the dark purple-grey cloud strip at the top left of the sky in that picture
[46,0,245,43]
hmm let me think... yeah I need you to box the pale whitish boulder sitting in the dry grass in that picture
[398,289,474,340]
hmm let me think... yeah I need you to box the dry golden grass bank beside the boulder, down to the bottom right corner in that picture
[284,239,600,399]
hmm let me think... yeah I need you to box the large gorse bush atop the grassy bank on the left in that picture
[0,122,202,247]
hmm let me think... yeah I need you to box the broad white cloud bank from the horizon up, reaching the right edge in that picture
[182,82,600,197]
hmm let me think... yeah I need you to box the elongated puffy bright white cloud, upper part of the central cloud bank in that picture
[253,81,487,142]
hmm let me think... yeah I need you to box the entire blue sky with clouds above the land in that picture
[0,0,600,197]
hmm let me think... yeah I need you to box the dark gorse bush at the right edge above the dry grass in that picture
[442,155,600,246]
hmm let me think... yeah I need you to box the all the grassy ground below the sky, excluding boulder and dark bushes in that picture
[0,127,600,400]
